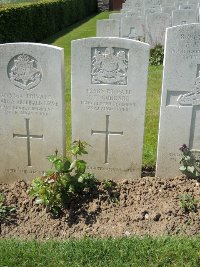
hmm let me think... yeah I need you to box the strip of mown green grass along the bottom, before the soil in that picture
[0,237,200,267]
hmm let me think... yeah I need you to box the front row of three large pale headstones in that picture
[0,24,200,182]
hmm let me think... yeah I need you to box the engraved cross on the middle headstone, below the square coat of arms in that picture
[91,115,123,163]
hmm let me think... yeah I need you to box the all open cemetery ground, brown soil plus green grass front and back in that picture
[0,13,200,267]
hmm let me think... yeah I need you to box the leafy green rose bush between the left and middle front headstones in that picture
[29,141,95,216]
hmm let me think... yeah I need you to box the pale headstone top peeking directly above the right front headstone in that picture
[172,9,197,26]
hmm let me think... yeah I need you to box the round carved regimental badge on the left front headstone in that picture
[7,54,42,90]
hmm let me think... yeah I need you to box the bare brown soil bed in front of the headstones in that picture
[0,176,200,240]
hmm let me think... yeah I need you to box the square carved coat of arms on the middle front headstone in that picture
[91,47,128,85]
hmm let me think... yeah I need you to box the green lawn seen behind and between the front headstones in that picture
[44,12,162,167]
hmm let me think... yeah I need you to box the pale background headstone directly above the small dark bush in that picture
[145,13,170,47]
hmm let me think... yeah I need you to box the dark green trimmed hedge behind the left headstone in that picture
[0,0,97,43]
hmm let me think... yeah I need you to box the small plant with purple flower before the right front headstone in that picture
[179,144,200,178]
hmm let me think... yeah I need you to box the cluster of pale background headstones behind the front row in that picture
[97,0,199,47]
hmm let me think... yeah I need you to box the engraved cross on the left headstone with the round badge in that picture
[13,119,43,167]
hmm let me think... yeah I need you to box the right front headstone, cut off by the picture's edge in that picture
[156,24,200,177]
